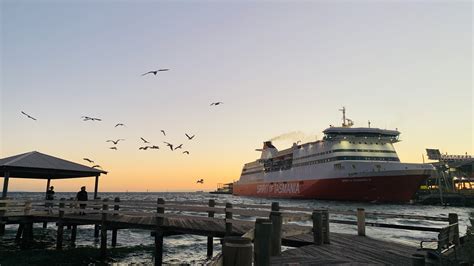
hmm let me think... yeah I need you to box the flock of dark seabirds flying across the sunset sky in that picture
[21,68,223,184]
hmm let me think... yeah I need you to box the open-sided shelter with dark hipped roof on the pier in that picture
[0,151,107,199]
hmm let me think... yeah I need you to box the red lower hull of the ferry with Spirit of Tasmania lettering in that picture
[233,175,428,202]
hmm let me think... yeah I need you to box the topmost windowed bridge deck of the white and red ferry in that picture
[323,127,400,143]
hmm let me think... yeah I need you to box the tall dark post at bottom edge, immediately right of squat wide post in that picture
[254,218,272,266]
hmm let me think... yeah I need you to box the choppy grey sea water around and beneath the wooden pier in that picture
[0,192,473,264]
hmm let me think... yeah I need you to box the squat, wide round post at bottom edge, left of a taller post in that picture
[222,236,252,266]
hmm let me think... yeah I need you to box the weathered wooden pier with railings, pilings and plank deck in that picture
[0,198,457,265]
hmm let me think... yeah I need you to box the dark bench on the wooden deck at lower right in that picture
[418,223,459,262]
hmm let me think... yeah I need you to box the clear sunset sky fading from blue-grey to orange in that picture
[0,0,474,192]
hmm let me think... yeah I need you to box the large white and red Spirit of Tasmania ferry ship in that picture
[233,108,434,202]
